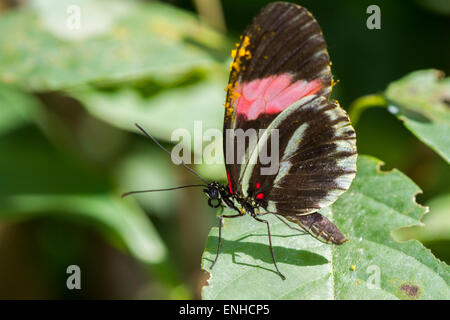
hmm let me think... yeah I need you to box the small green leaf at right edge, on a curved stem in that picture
[385,70,450,163]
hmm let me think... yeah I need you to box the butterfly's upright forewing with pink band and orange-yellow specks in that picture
[224,2,332,191]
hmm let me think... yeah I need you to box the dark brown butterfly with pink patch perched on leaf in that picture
[122,2,357,280]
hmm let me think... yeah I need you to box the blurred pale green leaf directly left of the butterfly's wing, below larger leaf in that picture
[70,79,226,142]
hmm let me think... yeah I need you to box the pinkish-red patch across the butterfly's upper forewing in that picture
[234,73,323,120]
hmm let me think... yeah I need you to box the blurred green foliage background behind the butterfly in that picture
[0,0,450,299]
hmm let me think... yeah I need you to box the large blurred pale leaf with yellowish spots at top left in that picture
[0,0,224,91]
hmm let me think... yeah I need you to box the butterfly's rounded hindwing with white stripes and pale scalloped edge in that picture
[242,96,357,215]
